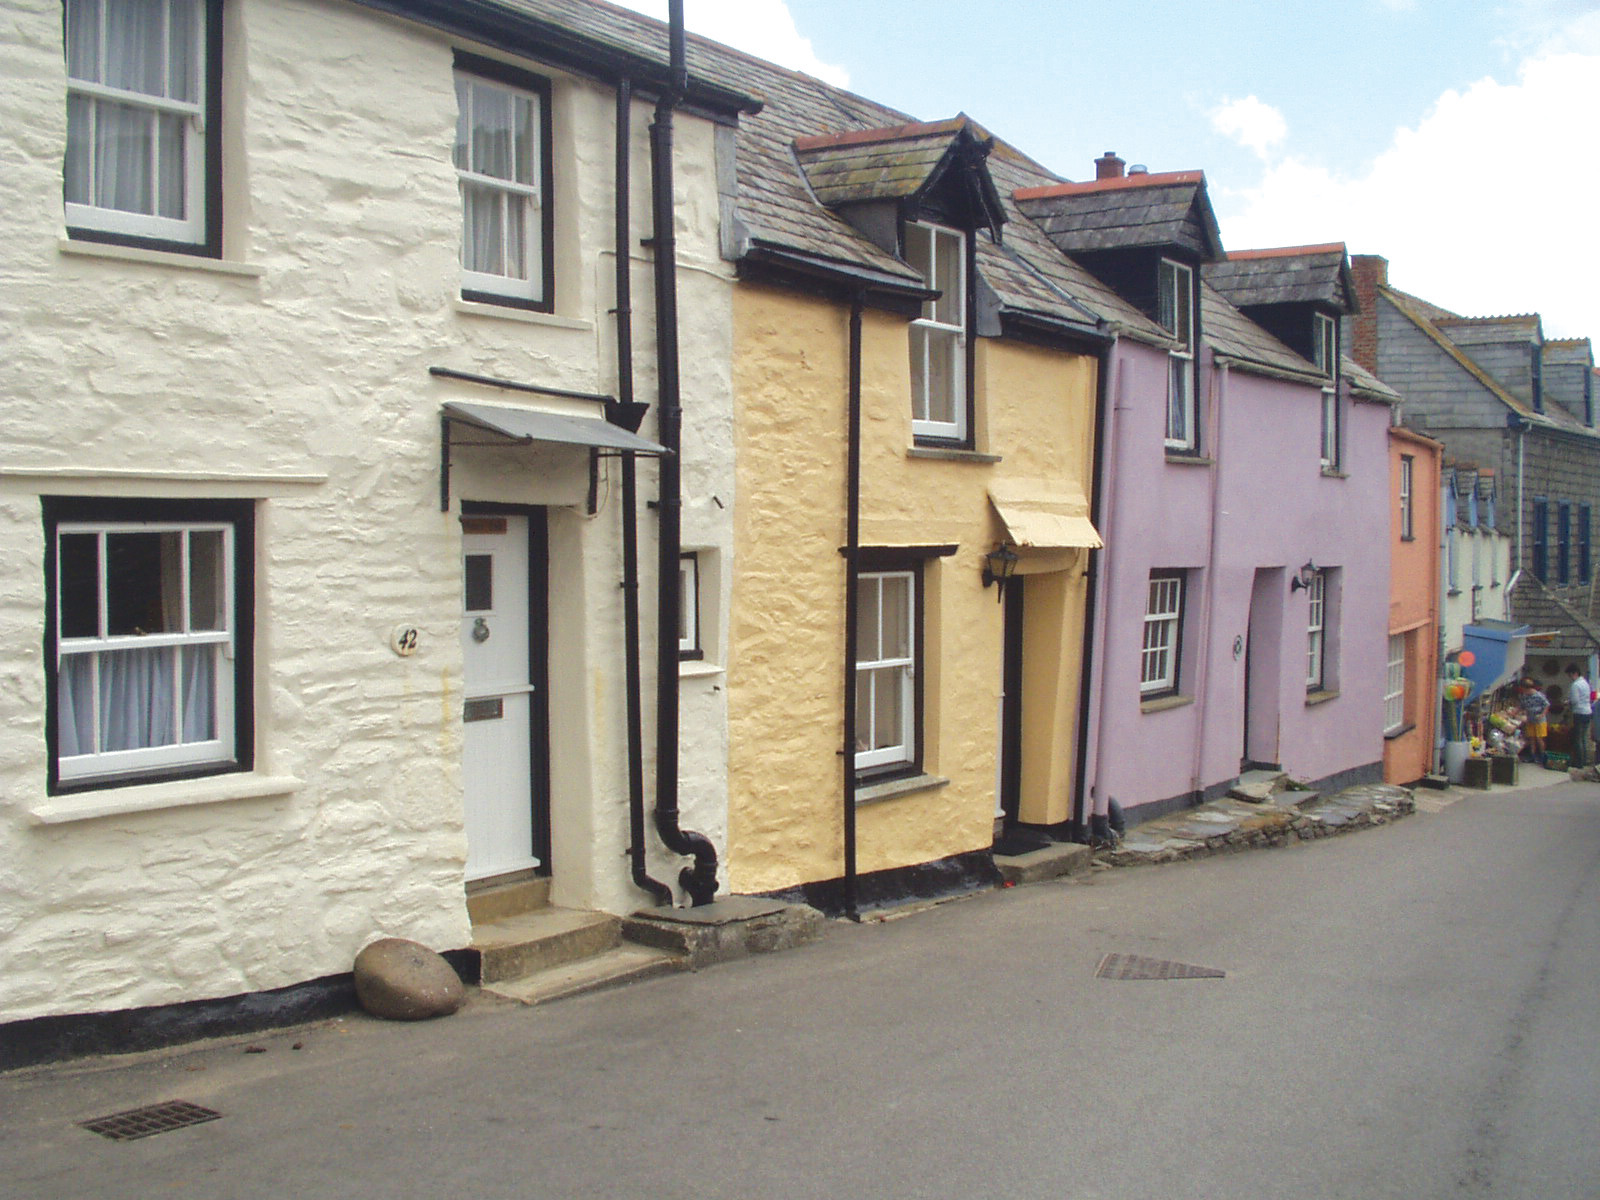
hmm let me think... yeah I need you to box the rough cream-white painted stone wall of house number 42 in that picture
[0,0,731,1021]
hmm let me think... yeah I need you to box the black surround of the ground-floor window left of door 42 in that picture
[40,496,256,795]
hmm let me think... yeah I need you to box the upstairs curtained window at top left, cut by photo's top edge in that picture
[62,0,219,250]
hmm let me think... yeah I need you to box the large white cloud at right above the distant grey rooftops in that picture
[1218,53,1600,341]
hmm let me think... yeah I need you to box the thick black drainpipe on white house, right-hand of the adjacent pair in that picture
[650,0,717,907]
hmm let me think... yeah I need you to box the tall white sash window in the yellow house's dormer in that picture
[904,221,970,443]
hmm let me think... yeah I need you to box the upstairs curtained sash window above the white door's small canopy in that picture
[454,54,550,309]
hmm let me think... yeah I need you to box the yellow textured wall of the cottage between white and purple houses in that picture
[728,283,1098,893]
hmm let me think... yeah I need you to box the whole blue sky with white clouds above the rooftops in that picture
[608,0,1600,344]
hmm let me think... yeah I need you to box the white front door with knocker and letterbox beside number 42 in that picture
[461,515,539,880]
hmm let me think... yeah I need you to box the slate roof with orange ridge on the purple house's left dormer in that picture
[1014,171,1224,259]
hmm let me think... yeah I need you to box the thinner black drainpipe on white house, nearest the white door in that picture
[614,78,672,904]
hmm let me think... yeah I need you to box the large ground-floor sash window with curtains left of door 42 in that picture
[45,501,253,789]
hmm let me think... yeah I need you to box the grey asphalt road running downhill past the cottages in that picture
[0,784,1600,1200]
